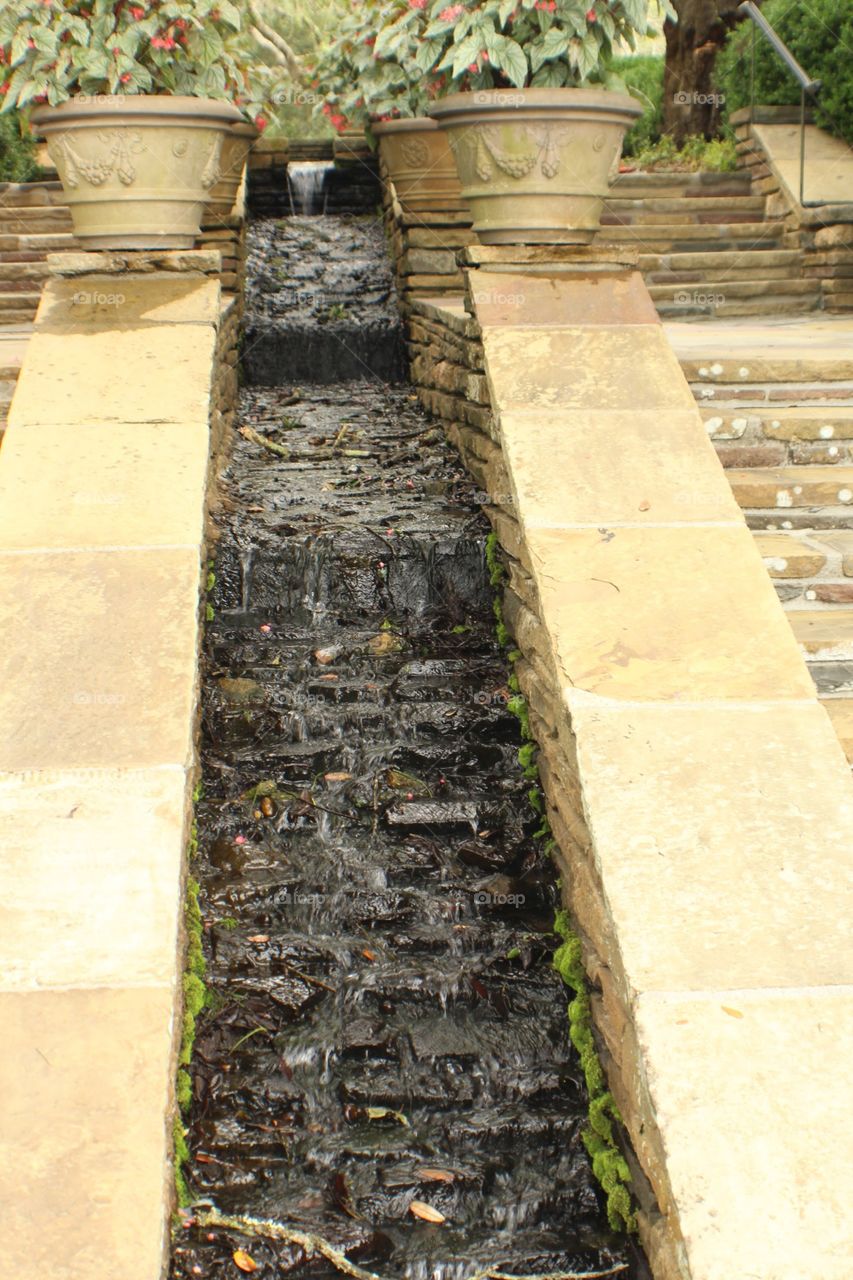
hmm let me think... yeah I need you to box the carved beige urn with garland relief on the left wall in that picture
[32,93,242,250]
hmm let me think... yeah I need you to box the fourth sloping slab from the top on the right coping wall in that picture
[526,522,815,701]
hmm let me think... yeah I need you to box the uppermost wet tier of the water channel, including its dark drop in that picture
[243,214,405,387]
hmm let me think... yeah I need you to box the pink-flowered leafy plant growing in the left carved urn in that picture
[0,0,273,128]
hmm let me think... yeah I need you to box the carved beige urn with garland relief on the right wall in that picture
[430,88,642,244]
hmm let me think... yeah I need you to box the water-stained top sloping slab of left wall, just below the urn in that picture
[36,274,220,333]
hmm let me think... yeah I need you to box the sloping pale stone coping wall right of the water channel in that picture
[410,248,853,1280]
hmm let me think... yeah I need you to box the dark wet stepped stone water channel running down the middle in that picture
[170,218,648,1280]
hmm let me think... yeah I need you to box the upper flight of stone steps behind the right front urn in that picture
[598,173,821,319]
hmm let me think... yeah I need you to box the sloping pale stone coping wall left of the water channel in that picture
[0,251,238,1280]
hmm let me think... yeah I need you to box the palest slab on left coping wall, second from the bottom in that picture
[0,765,188,991]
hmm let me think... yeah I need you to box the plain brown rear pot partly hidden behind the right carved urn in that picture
[373,116,467,214]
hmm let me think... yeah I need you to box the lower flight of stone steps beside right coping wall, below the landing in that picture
[667,316,853,763]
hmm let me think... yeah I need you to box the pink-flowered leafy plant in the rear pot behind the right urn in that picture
[313,0,439,132]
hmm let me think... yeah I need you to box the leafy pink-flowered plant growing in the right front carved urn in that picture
[416,0,676,93]
